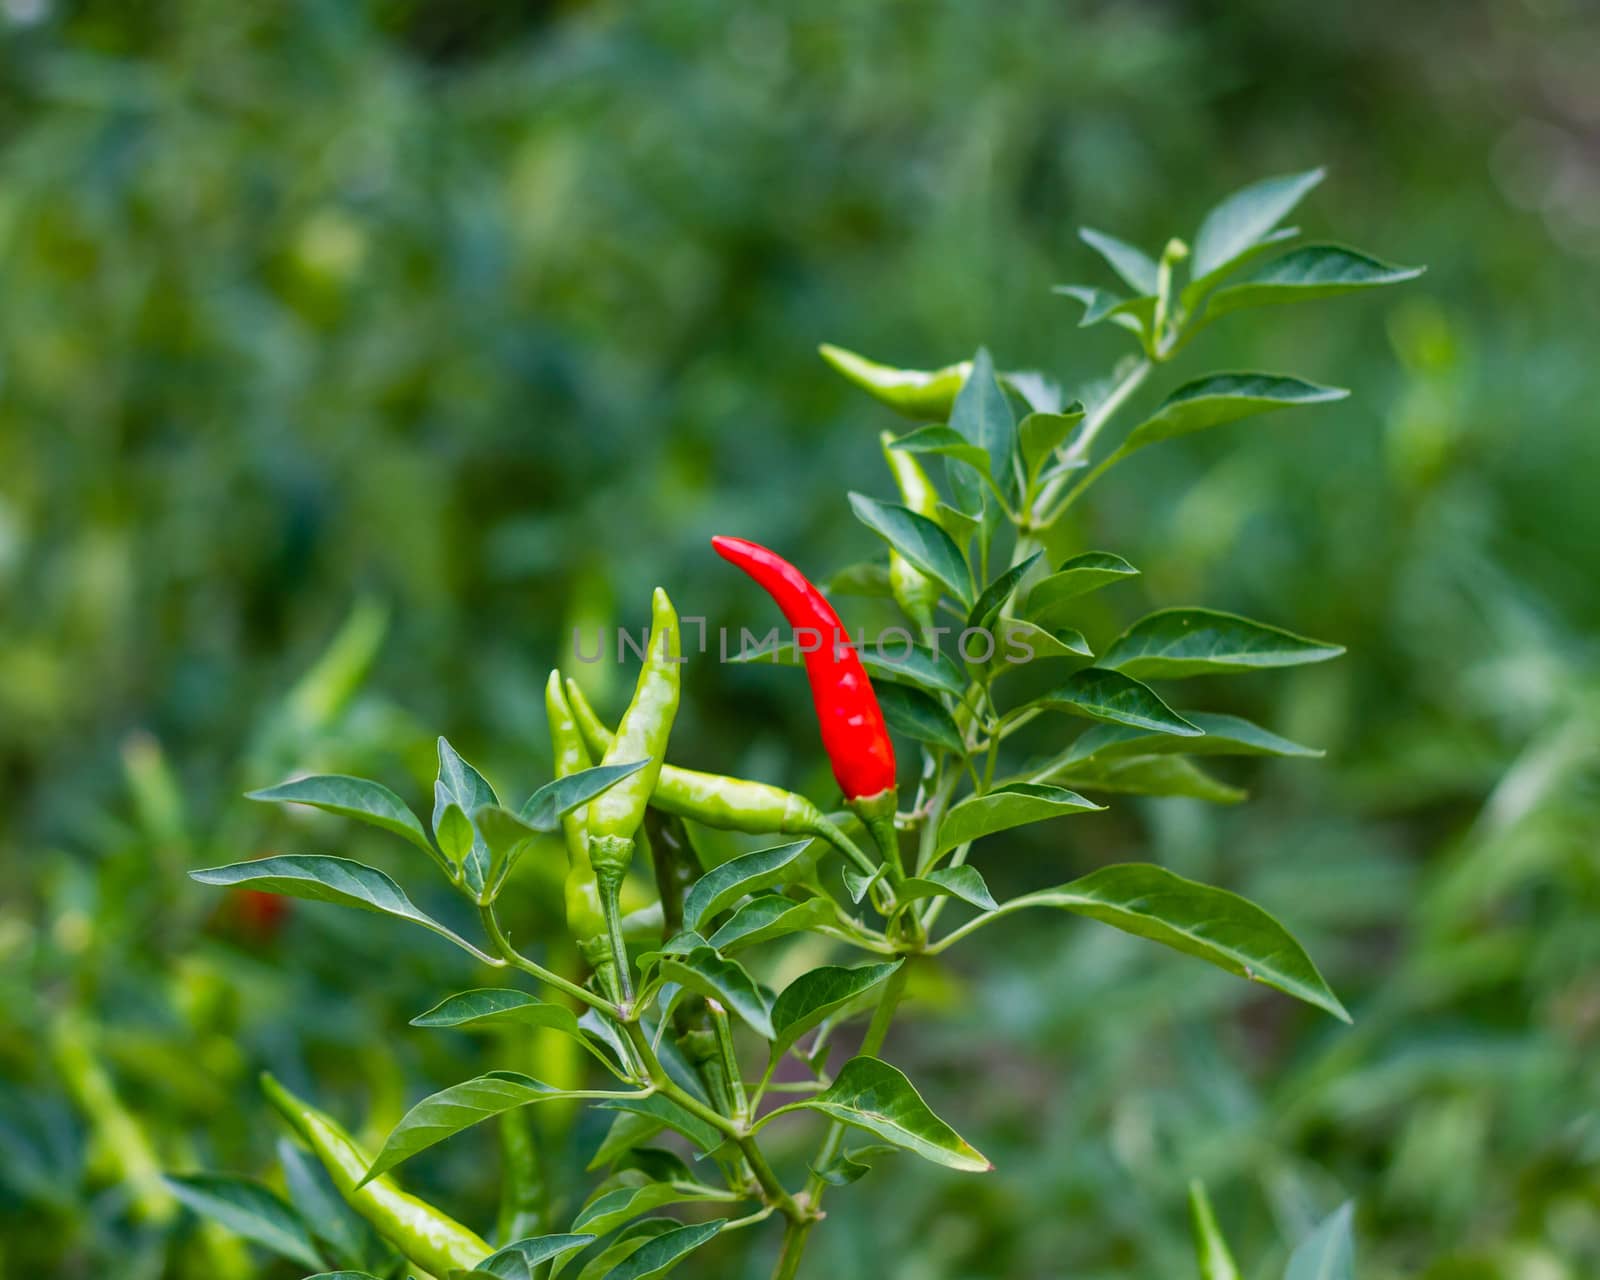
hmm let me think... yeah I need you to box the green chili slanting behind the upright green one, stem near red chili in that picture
[566,680,877,875]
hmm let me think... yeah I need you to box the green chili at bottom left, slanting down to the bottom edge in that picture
[261,1075,494,1275]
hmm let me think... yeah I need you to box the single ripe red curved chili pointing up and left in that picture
[710,538,894,800]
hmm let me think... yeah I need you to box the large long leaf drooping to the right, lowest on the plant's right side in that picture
[966,862,1350,1022]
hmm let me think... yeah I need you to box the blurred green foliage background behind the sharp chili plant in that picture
[0,0,1600,1280]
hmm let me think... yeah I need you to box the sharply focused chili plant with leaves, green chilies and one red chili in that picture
[181,171,1418,1280]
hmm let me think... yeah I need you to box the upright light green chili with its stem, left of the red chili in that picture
[587,587,683,1005]
